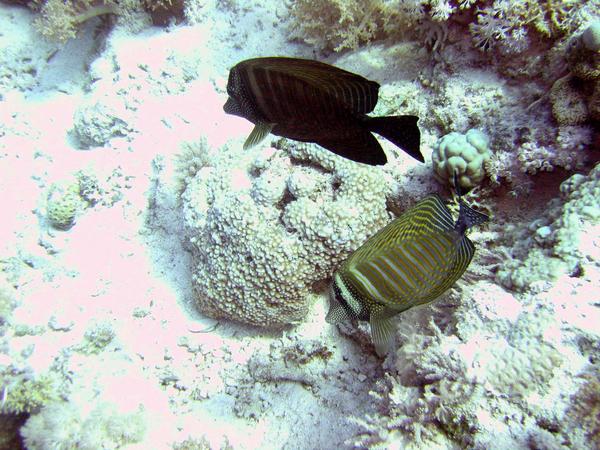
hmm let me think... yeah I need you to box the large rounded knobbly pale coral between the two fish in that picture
[181,143,390,327]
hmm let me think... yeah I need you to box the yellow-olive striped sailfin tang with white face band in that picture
[326,195,488,355]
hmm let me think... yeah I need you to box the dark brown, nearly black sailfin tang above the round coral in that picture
[223,57,424,165]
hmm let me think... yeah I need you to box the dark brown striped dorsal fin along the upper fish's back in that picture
[244,57,379,114]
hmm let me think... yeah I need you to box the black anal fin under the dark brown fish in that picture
[315,130,387,166]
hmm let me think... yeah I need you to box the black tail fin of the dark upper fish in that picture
[367,116,425,162]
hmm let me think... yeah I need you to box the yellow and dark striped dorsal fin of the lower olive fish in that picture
[346,194,454,267]
